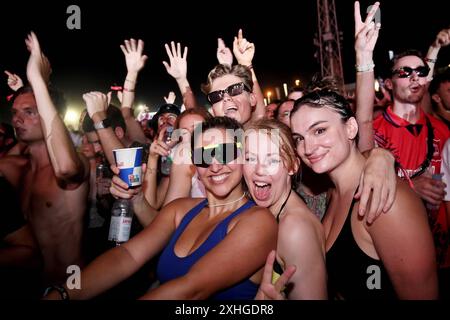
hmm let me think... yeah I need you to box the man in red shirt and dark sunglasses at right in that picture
[373,50,450,278]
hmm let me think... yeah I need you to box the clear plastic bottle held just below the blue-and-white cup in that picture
[108,199,133,246]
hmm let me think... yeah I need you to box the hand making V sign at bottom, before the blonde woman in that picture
[255,250,296,300]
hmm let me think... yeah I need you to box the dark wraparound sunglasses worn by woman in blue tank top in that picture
[192,142,242,168]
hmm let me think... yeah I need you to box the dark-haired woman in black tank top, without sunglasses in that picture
[291,90,438,299]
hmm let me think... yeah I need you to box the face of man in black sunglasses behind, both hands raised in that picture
[209,74,256,124]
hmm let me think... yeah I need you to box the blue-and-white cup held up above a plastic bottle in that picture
[113,147,143,187]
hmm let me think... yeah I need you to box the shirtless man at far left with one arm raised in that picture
[0,33,89,285]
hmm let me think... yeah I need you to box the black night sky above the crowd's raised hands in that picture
[0,0,450,124]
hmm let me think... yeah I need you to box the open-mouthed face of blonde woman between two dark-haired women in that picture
[244,130,295,208]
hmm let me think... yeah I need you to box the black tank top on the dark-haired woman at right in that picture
[326,199,396,300]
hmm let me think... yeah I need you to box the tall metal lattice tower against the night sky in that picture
[314,0,344,89]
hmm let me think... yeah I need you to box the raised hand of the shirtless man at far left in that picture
[25,32,52,84]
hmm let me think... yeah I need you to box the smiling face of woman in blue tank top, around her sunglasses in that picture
[194,128,243,198]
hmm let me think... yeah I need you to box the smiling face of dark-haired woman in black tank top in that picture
[291,104,358,173]
